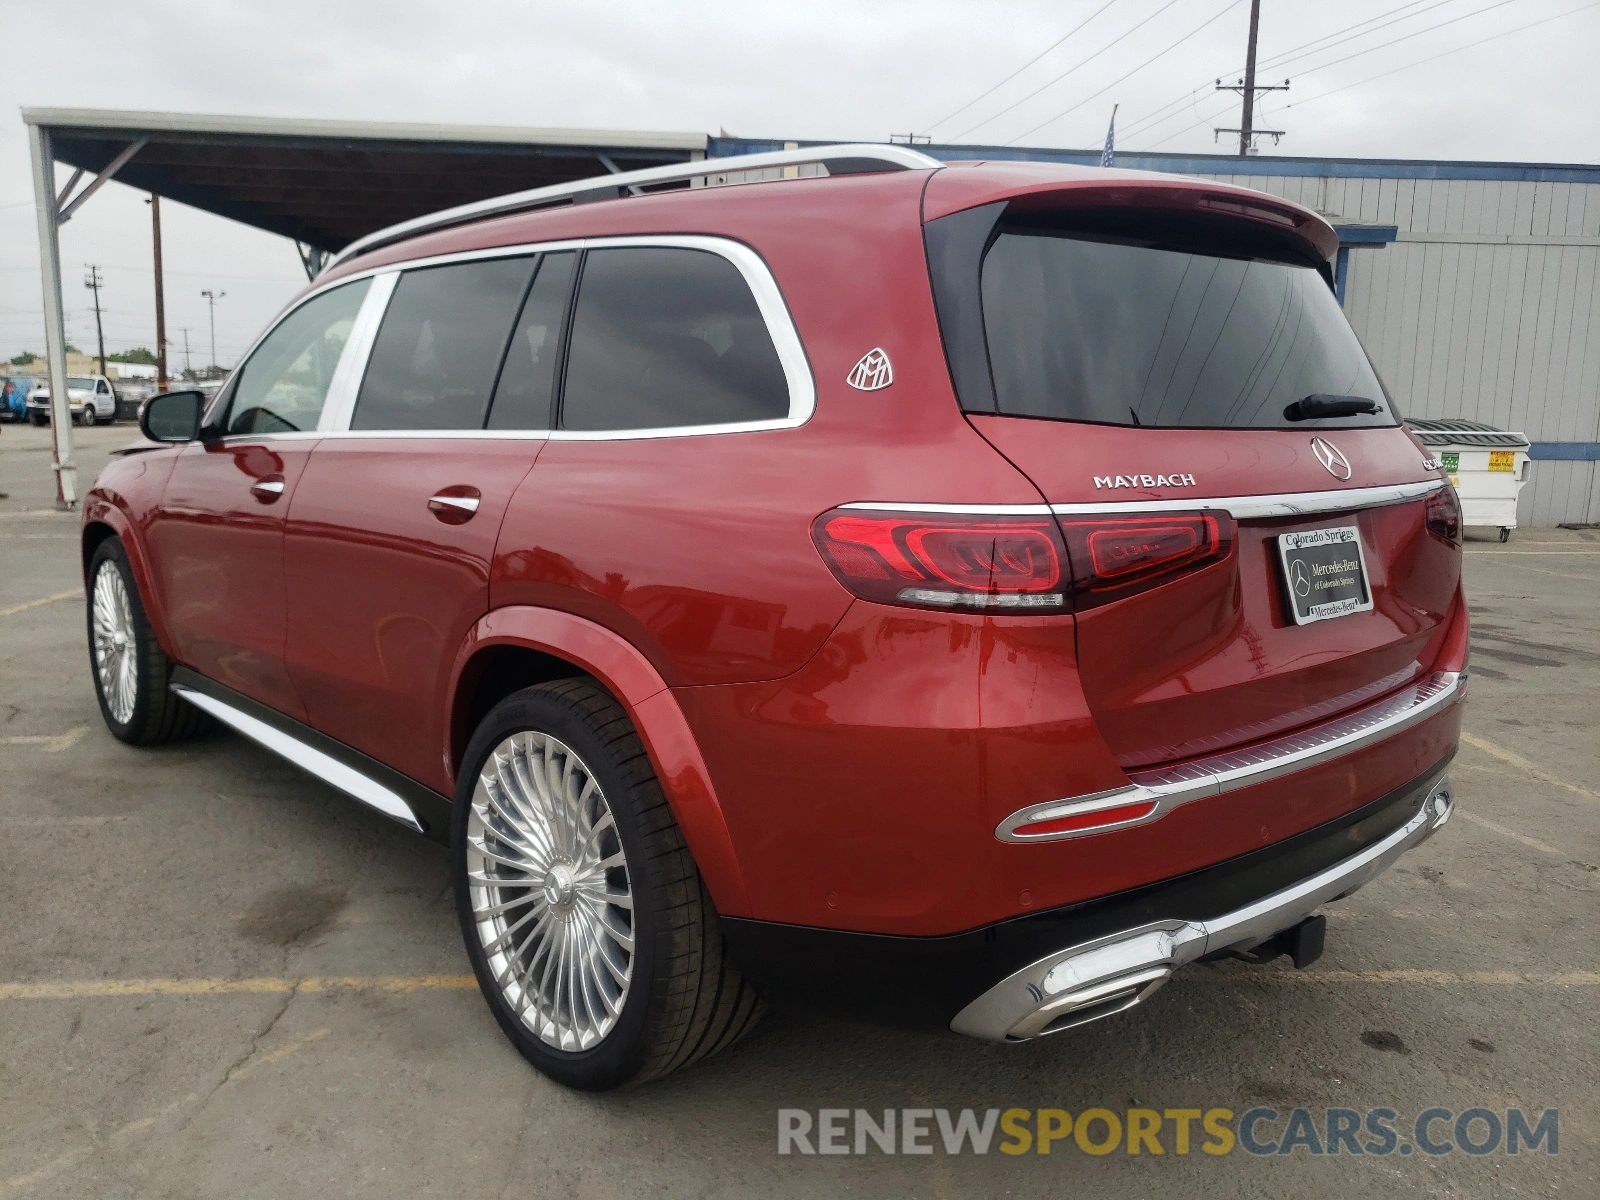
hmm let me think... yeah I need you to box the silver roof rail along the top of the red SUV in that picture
[323,144,944,270]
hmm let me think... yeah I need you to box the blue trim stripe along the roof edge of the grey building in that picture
[706,138,1600,184]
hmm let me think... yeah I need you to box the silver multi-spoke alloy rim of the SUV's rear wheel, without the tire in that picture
[466,731,634,1051]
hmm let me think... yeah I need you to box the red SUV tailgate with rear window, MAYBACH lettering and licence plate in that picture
[934,200,1459,768]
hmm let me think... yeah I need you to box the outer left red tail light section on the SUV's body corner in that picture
[811,509,1067,613]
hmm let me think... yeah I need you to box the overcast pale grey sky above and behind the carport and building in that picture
[0,0,1600,366]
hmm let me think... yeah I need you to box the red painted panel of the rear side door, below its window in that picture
[285,437,544,795]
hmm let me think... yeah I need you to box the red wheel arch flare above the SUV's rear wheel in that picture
[443,605,749,917]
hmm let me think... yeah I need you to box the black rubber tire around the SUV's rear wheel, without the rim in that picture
[451,678,765,1091]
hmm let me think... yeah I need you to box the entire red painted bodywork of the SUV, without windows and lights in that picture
[88,165,1466,953]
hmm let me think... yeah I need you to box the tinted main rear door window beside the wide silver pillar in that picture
[350,258,534,429]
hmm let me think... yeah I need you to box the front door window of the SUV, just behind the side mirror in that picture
[226,280,370,434]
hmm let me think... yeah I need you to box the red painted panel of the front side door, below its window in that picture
[146,437,317,720]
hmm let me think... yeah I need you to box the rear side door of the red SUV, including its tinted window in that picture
[286,250,576,794]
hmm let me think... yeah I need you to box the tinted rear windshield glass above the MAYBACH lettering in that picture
[982,232,1397,429]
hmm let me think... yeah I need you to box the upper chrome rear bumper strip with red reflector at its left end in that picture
[995,670,1467,843]
